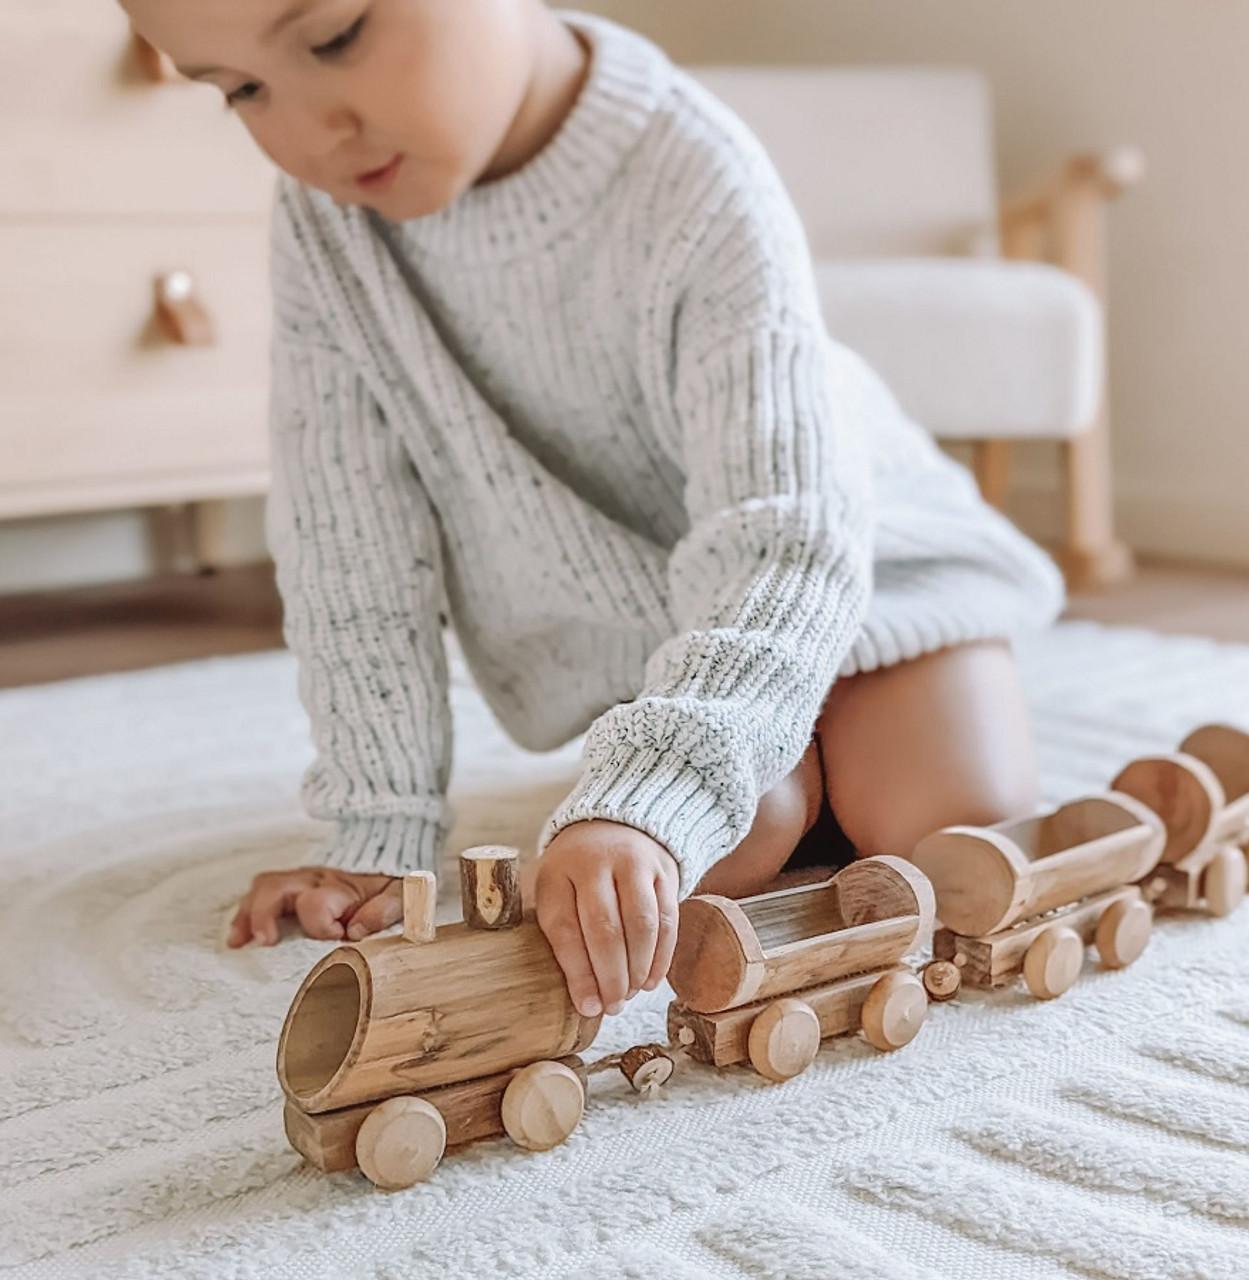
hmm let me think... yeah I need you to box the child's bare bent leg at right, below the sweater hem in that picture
[815,643,1040,858]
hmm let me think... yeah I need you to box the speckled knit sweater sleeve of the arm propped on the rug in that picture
[266,197,452,876]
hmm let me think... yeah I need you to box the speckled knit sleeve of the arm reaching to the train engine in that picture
[541,127,871,896]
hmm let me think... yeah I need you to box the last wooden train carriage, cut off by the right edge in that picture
[1113,724,1249,915]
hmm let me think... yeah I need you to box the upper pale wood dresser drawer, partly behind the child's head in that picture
[0,0,276,218]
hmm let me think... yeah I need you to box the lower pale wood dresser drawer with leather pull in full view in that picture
[0,220,270,517]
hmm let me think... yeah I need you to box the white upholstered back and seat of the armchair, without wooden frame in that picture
[691,67,1104,439]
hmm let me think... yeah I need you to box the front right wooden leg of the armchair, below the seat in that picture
[1057,406,1135,594]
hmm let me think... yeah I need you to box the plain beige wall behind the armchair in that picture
[584,0,1249,564]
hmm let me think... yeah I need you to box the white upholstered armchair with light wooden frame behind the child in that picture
[691,67,1143,590]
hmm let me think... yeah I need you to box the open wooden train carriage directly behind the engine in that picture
[668,858,933,1080]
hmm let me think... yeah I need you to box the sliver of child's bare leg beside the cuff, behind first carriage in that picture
[697,739,824,897]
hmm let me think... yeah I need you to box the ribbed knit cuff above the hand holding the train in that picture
[537,744,756,899]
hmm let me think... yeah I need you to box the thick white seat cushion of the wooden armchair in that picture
[816,259,1104,439]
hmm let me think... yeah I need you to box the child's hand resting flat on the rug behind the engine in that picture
[229,867,403,947]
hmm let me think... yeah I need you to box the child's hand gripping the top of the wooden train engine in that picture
[536,820,680,1018]
